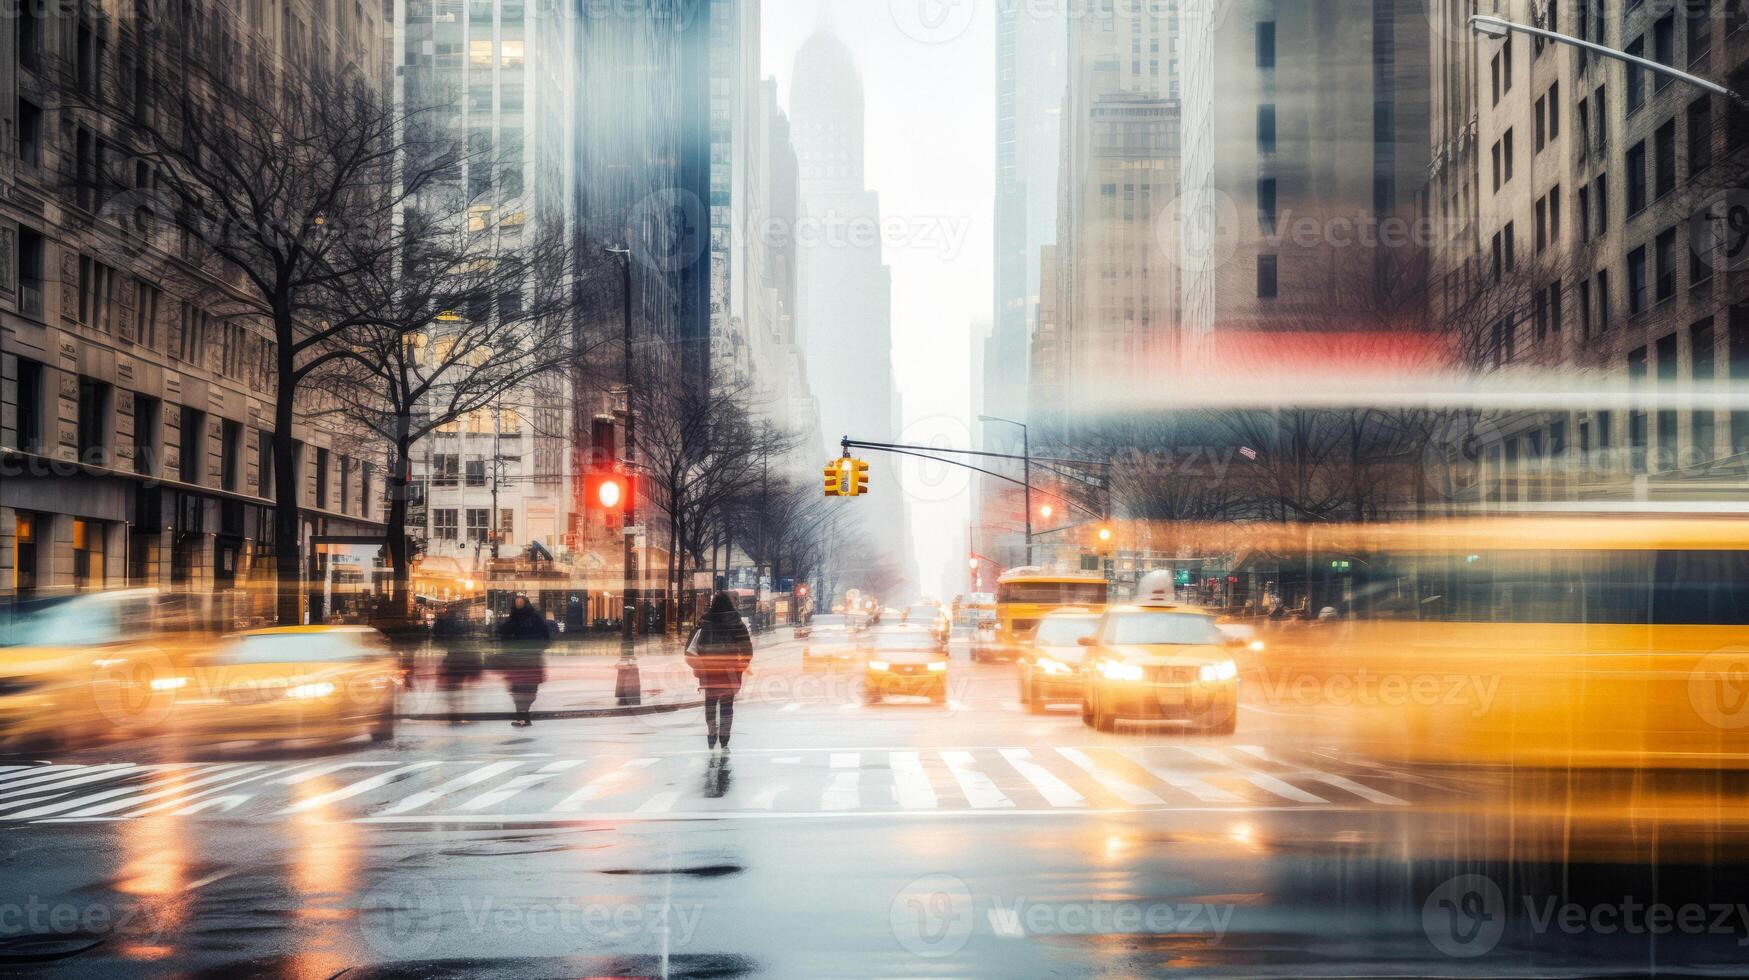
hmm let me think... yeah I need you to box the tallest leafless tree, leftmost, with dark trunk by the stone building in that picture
[63,5,458,623]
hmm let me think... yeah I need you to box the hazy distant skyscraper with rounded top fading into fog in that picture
[789,30,909,584]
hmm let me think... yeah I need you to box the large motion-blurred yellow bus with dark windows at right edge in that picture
[1247,511,1749,768]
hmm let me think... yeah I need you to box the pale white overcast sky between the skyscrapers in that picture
[761,0,995,599]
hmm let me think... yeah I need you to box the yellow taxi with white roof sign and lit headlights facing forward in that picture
[1079,572,1240,735]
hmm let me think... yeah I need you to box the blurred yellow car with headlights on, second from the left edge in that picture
[142,627,401,742]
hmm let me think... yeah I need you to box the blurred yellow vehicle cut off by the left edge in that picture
[0,588,198,747]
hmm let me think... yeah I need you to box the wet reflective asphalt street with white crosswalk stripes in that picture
[0,630,1749,977]
